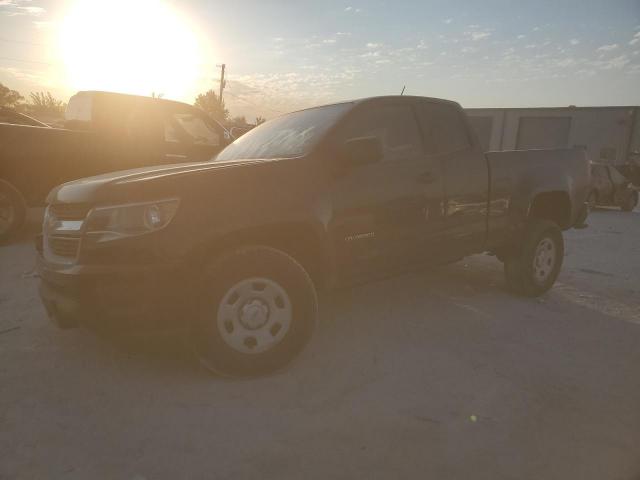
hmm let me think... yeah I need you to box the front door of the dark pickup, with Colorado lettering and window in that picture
[332,100,442,280]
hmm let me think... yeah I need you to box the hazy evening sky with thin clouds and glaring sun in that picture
[0,0,640,120]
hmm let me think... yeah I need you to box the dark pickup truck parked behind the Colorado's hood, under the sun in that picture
[0,92,229,241]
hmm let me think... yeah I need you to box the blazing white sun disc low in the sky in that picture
[59,0,202,99]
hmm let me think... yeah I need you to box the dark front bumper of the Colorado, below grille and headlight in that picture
[37,255,196,333]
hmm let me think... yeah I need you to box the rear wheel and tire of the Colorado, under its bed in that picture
[504,219,564,297]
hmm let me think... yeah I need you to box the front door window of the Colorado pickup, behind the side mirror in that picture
[342,105,422,162]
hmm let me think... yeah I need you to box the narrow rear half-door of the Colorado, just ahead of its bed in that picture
[419,100,489,260]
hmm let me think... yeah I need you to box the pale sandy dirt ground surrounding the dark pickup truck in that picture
[0,210,640,480]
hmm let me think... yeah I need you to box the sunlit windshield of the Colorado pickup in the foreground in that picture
[215,103,351,161]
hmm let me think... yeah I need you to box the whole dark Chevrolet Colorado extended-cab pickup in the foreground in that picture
[37,97,590,376]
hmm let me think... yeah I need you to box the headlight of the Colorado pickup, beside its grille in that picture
[85,198,180,242]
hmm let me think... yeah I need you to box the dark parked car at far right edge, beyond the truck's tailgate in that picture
[588,163,638,212]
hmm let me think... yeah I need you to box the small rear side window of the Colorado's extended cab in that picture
[420,102,471,154]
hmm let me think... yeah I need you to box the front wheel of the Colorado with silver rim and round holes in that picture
[191,246,318,377]
